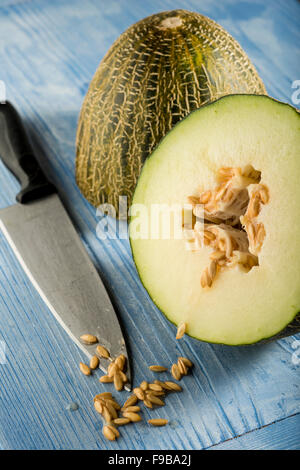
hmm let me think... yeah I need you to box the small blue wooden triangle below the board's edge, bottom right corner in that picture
[209,414,300,450]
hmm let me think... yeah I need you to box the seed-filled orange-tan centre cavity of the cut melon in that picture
[188,165,269,288]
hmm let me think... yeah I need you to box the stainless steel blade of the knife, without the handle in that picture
[0,194,131,390]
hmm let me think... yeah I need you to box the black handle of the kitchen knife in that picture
[0,102,56,204]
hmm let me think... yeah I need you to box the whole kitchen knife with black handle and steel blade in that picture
[0,102,131,390]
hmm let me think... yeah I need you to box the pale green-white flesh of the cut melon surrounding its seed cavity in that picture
[130,95,300,346]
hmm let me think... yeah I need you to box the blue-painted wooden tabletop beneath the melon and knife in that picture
[0,0,300,449]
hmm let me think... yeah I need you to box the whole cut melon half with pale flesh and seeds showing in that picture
[130,95,300,345]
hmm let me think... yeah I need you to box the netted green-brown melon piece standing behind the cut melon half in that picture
[76,10,266,213]
